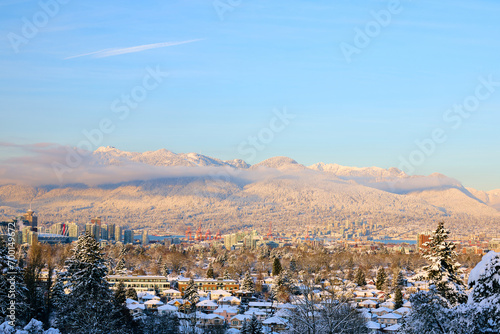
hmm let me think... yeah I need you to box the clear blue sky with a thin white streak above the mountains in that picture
[0,0,500,190]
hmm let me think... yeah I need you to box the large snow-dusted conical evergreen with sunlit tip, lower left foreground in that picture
[57,233,130,334]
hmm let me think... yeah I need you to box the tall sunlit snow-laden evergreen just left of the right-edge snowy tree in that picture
[422,222,467,307]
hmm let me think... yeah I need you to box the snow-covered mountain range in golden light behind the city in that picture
[0,147,500,234]
